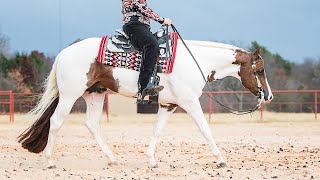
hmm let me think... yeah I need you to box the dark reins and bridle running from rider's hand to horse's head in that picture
[167,24,264,115]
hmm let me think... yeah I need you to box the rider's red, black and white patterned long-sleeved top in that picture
[122,0,164,26]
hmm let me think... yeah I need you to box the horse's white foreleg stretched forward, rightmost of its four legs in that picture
[179,98,226,168]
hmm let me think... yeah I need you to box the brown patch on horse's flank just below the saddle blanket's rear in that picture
[87,61,119,93]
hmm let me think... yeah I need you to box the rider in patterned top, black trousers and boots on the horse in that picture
[122,0,172,98]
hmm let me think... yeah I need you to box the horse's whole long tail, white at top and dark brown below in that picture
[18,55,59,153]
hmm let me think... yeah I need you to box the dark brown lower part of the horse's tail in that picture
[18,97,59,153]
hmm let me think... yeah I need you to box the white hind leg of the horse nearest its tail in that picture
[45,96,77,168]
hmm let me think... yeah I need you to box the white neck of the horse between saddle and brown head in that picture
[182,41,240,79]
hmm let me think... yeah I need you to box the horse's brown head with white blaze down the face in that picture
[233,49,273,102]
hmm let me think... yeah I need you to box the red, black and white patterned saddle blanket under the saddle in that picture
[97,33,178,73]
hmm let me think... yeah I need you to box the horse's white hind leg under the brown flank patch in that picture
[83,93,116,164]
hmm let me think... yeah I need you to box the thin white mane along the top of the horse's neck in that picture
[182,40,247,52]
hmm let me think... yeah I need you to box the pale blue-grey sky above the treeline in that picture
[0,0,320,62]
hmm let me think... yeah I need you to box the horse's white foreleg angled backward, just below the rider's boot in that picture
[147,107,176,168]
